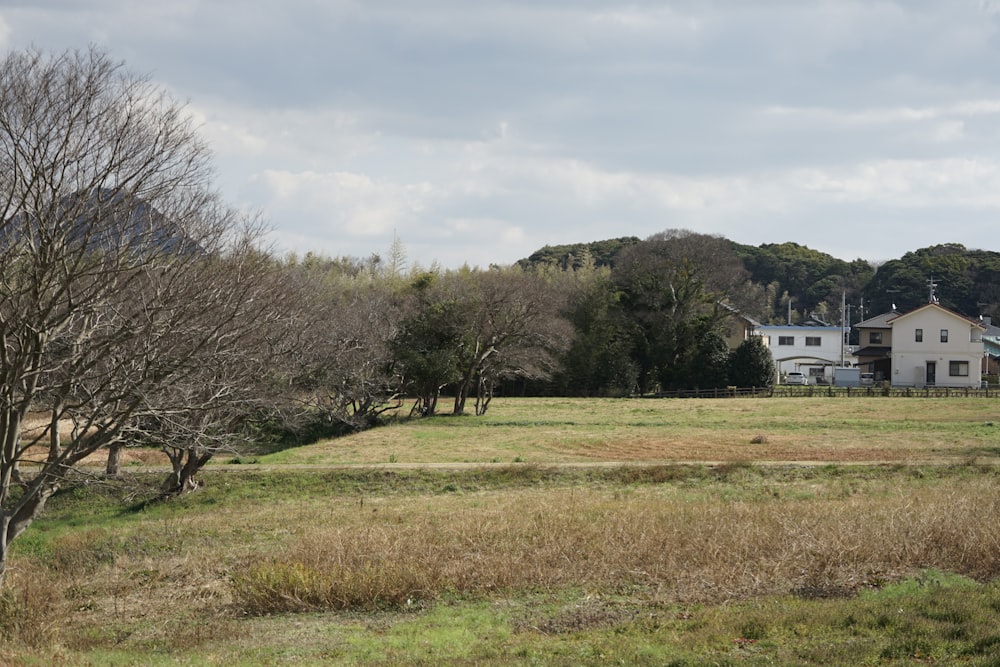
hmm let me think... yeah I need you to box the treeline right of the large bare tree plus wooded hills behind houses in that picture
[281,230,1000,412]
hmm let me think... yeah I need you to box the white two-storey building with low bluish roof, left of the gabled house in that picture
[756,324,851,384]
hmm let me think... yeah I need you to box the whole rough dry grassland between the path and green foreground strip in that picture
[0,464,1000,664]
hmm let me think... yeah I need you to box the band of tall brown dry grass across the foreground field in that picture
[235,474,1000,613]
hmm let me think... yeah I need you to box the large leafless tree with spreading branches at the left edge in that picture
[0,49,276,584]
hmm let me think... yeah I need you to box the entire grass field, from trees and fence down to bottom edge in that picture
[0,398,1000,665]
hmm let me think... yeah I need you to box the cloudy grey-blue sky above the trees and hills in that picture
[0,0,1000,267]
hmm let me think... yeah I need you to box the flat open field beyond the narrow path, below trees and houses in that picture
[259,398,1000,465]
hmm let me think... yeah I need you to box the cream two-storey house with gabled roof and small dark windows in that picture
[888,302,986,388]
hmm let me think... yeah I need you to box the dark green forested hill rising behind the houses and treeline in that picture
[518,237,1000,322]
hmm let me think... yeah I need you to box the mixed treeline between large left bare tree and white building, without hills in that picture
[277,231,773,428]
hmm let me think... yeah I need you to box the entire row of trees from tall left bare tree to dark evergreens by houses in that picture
[0,49,760,584]
